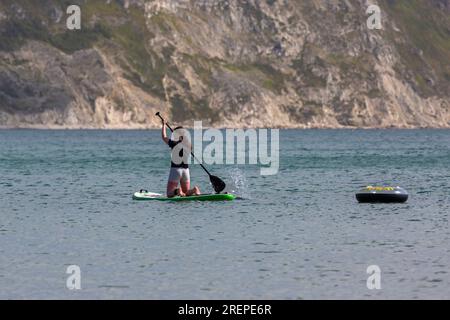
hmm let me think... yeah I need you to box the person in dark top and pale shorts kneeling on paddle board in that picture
[161,120,200,198]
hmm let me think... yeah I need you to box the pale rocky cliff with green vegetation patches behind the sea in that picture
[0,0,450,128]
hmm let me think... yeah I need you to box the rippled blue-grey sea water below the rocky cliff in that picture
[0,130,450,299]
